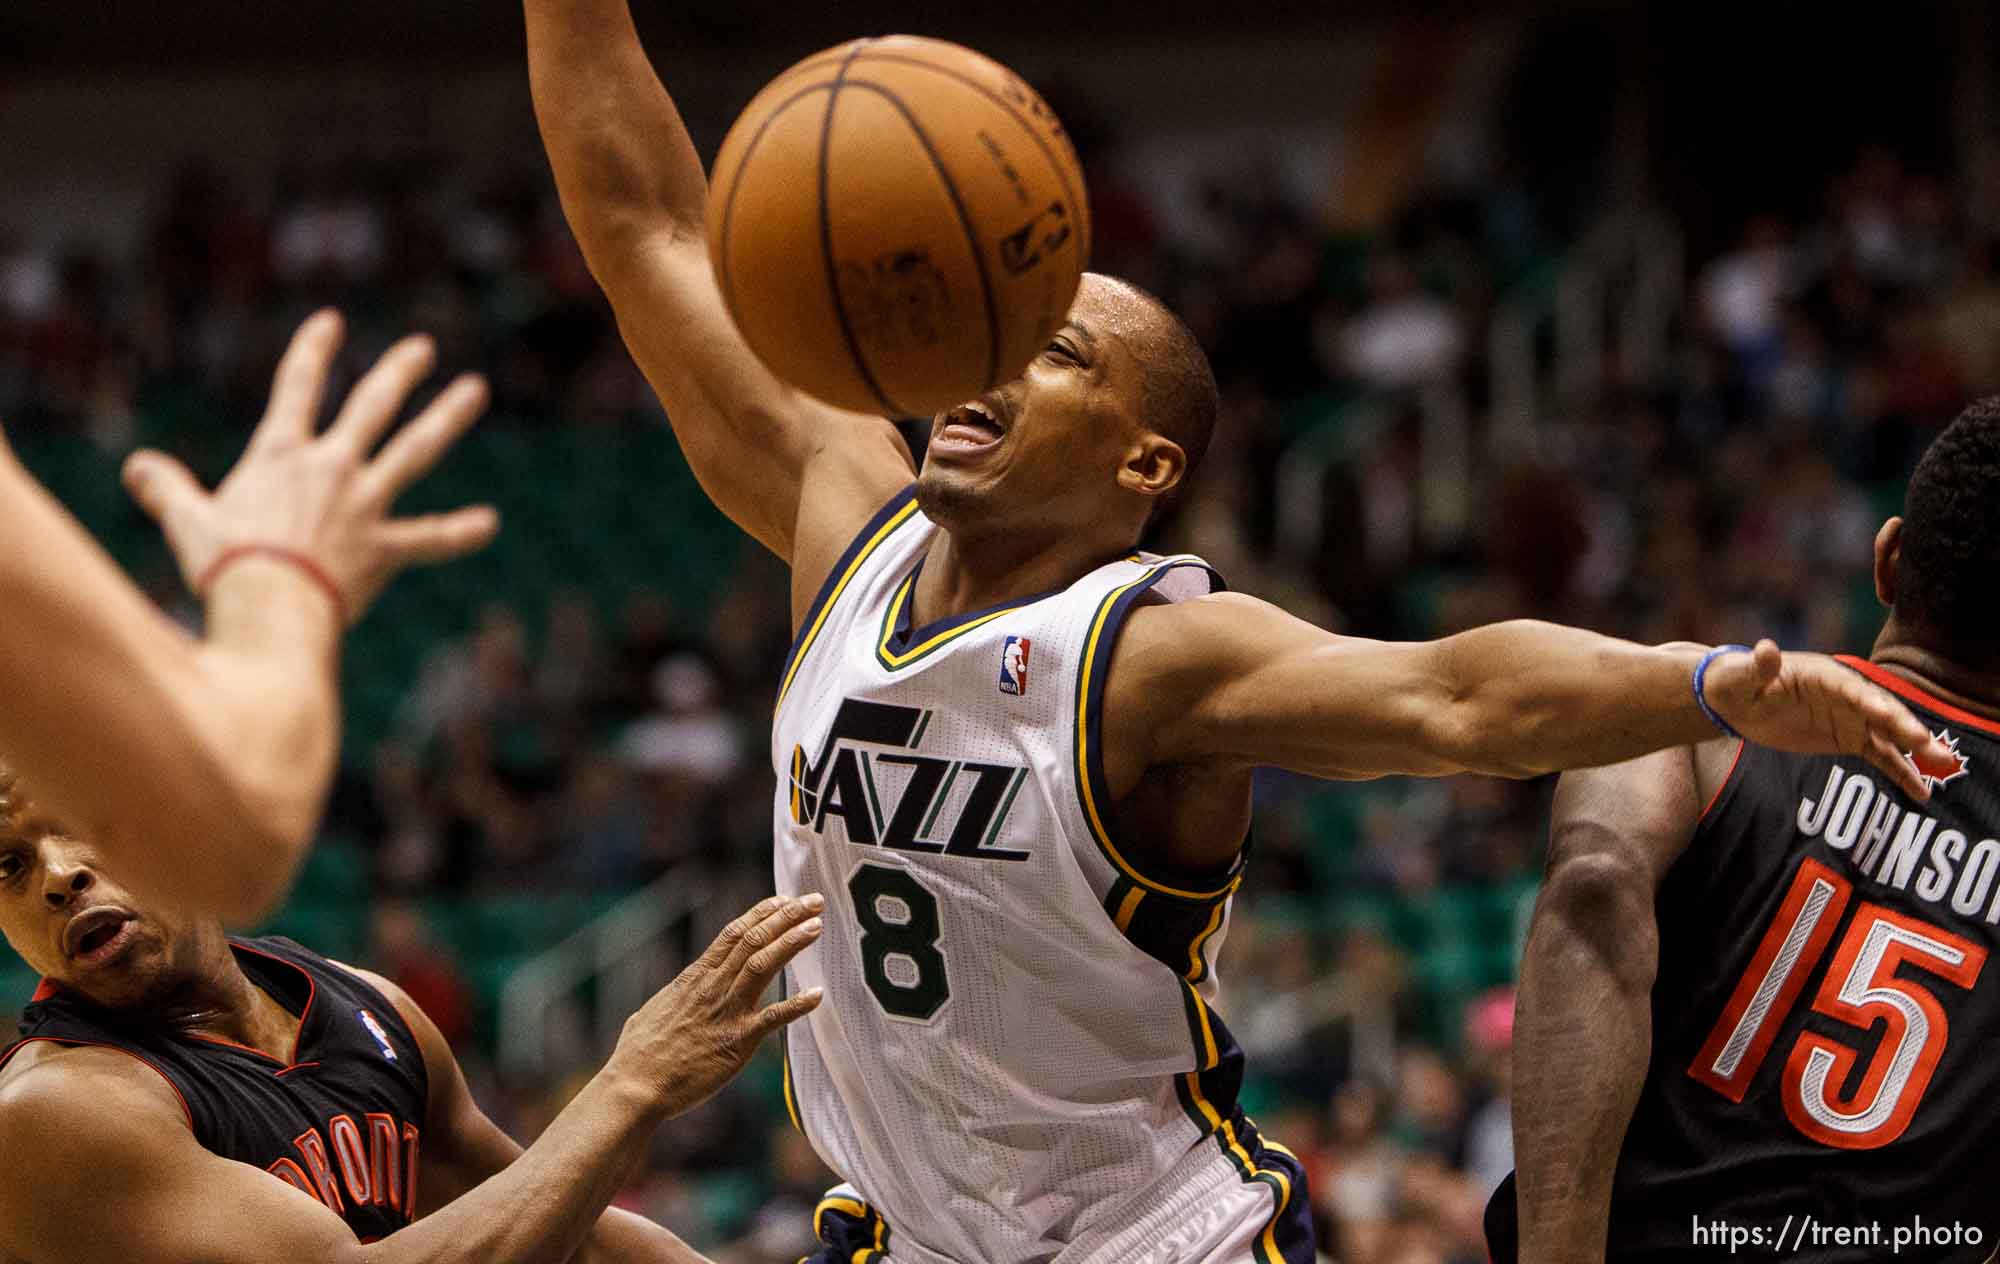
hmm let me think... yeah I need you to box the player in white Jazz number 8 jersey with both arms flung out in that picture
[526,0,1942,1264]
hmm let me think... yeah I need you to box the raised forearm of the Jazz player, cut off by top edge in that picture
[526,0,706,254]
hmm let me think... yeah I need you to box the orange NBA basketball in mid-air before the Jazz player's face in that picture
[708,36,1090,416]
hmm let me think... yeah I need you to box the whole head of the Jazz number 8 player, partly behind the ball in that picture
[916,272,1218,548]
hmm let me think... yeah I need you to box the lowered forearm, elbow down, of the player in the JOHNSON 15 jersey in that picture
[1514,824,1660,1264]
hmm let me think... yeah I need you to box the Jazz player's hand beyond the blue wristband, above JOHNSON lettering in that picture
[1704,640,1956,800]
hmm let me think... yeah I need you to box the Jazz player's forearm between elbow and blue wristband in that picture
[1432,620,1716,776]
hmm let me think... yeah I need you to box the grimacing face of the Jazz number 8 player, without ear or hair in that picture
[916,276,1142,538]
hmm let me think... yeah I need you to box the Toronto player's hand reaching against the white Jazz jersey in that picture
[612,894,826,1114]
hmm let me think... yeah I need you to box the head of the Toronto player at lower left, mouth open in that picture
[0,766,228,1010]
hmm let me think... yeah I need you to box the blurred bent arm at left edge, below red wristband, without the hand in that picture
[0,452,338,922]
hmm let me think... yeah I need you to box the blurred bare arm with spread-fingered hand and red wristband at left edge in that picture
[0,312,496,922]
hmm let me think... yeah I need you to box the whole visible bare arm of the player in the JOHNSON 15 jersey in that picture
[1514,740,1736,1264]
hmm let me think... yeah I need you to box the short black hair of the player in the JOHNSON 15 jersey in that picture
[1896,396,2000,668]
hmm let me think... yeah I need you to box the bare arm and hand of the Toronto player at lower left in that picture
[0,898,820,1264]
